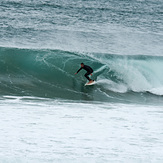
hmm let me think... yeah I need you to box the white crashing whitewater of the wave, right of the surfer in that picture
[95,56,163,95]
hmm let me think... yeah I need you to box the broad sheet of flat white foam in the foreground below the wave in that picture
[0,97,163,163]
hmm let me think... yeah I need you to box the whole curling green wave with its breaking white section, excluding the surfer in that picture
[0,47,163,104]
